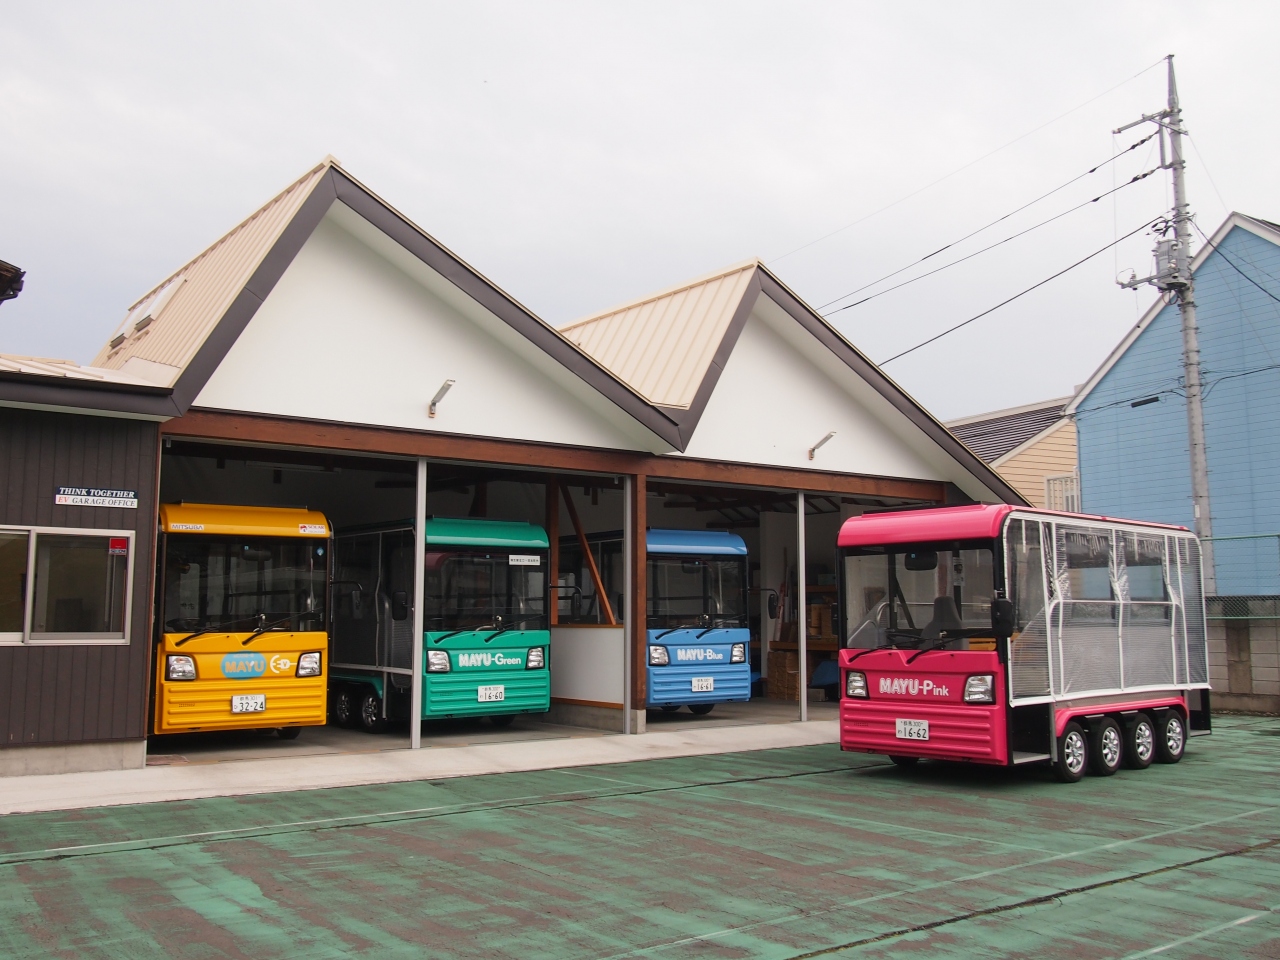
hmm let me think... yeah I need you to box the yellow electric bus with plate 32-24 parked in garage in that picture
[152,503,332,740]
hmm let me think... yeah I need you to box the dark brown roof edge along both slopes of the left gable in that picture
[173,166,684,449]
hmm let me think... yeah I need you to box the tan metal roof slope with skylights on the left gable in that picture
[93,156,338,387]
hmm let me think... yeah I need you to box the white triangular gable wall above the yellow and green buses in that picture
[195,204,652,449]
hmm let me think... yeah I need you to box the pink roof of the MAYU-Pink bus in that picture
[838,503,1187,547]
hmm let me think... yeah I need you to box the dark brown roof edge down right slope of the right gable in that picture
[758,264,1032,507]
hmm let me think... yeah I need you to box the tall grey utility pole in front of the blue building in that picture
[1112,54,1217,596]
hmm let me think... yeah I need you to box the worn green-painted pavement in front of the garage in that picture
[0,717,1280,960]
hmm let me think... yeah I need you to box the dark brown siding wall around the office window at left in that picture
[0,408,159,748]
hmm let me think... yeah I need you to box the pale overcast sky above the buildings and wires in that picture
[0,0,1280,417]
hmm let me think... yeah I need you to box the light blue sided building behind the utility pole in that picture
[1068,214,1280,596]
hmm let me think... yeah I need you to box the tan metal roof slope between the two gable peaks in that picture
[561,260,759,410]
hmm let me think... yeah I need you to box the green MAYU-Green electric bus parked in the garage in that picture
[329,517,550,733]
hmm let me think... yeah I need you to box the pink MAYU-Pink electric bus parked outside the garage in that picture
[840,504,1210,782]
